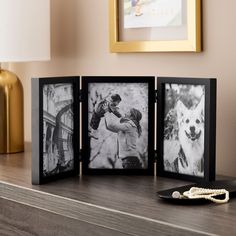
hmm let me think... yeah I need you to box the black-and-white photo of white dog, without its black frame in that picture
[164,85,205,177]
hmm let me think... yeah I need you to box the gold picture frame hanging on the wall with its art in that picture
[109,0,202,53]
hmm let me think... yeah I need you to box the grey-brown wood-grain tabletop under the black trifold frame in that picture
[0,145,236,236]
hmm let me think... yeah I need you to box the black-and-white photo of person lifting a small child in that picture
[82,77,156,174]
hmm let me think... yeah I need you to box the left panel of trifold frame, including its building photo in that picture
[32,77,79,184]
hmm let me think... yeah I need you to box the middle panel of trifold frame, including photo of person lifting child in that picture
[82,76,155,175]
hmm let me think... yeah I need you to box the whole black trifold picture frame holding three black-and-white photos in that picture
[32,76,216,184]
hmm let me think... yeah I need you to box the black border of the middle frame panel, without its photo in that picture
[82,76,155,175]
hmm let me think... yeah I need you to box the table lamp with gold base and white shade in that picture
[0,0,50,154]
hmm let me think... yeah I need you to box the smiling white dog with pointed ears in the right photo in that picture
[176,97,204,176]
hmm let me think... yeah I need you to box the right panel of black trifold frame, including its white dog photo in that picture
[157,77,216,182]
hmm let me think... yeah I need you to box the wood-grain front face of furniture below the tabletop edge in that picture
[0,198,127,236]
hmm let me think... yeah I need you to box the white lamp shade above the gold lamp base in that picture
[0,0,50,62]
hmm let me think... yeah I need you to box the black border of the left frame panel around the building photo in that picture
[32,76,80,184]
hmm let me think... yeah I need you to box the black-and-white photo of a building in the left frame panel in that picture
[43,83,74,176]
